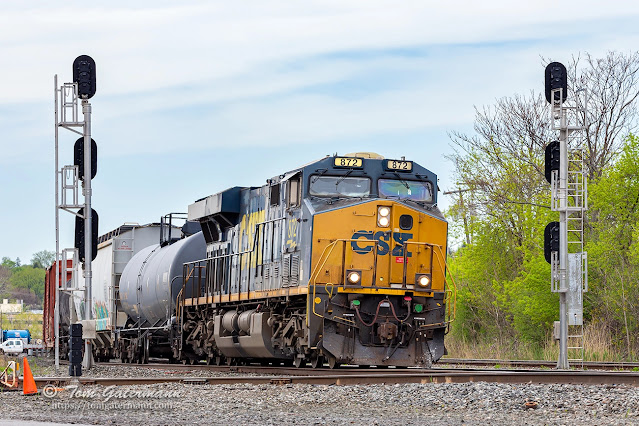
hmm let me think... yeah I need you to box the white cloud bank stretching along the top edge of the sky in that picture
[0,1,639,103]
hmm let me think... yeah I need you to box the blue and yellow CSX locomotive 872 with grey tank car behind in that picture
[46,153,455,368]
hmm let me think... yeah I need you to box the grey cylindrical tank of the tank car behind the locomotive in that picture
[120,232,206,327]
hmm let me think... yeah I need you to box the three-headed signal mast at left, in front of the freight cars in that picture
[53,55,98,376]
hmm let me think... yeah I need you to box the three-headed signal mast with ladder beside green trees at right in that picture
[544,62,588,369]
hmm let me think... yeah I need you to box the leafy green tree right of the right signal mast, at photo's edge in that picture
[586,135,639,355]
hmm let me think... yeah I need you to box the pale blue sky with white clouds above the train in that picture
[0,0,639,264]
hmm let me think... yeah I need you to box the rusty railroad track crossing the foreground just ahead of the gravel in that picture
[25,358,639,387]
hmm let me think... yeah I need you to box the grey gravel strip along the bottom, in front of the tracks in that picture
[0,382,639,425]
